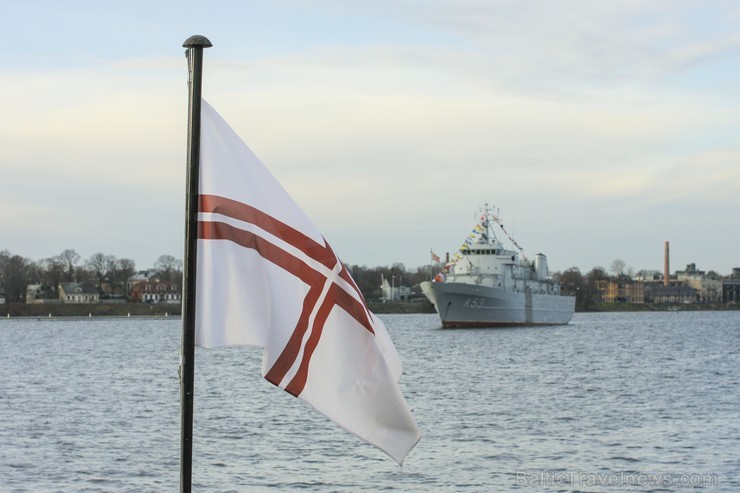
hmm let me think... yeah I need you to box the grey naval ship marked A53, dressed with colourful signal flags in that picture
[421,206,575,328]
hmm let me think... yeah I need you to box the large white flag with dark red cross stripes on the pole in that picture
[195,101,421,464]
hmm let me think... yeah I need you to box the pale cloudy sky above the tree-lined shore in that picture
[0,0,740,275]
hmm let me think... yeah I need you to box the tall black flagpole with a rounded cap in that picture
[180,32,212,493]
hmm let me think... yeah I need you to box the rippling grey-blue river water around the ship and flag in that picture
[0,312,740,492]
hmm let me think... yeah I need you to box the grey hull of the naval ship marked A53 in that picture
[421,282,575,328]
